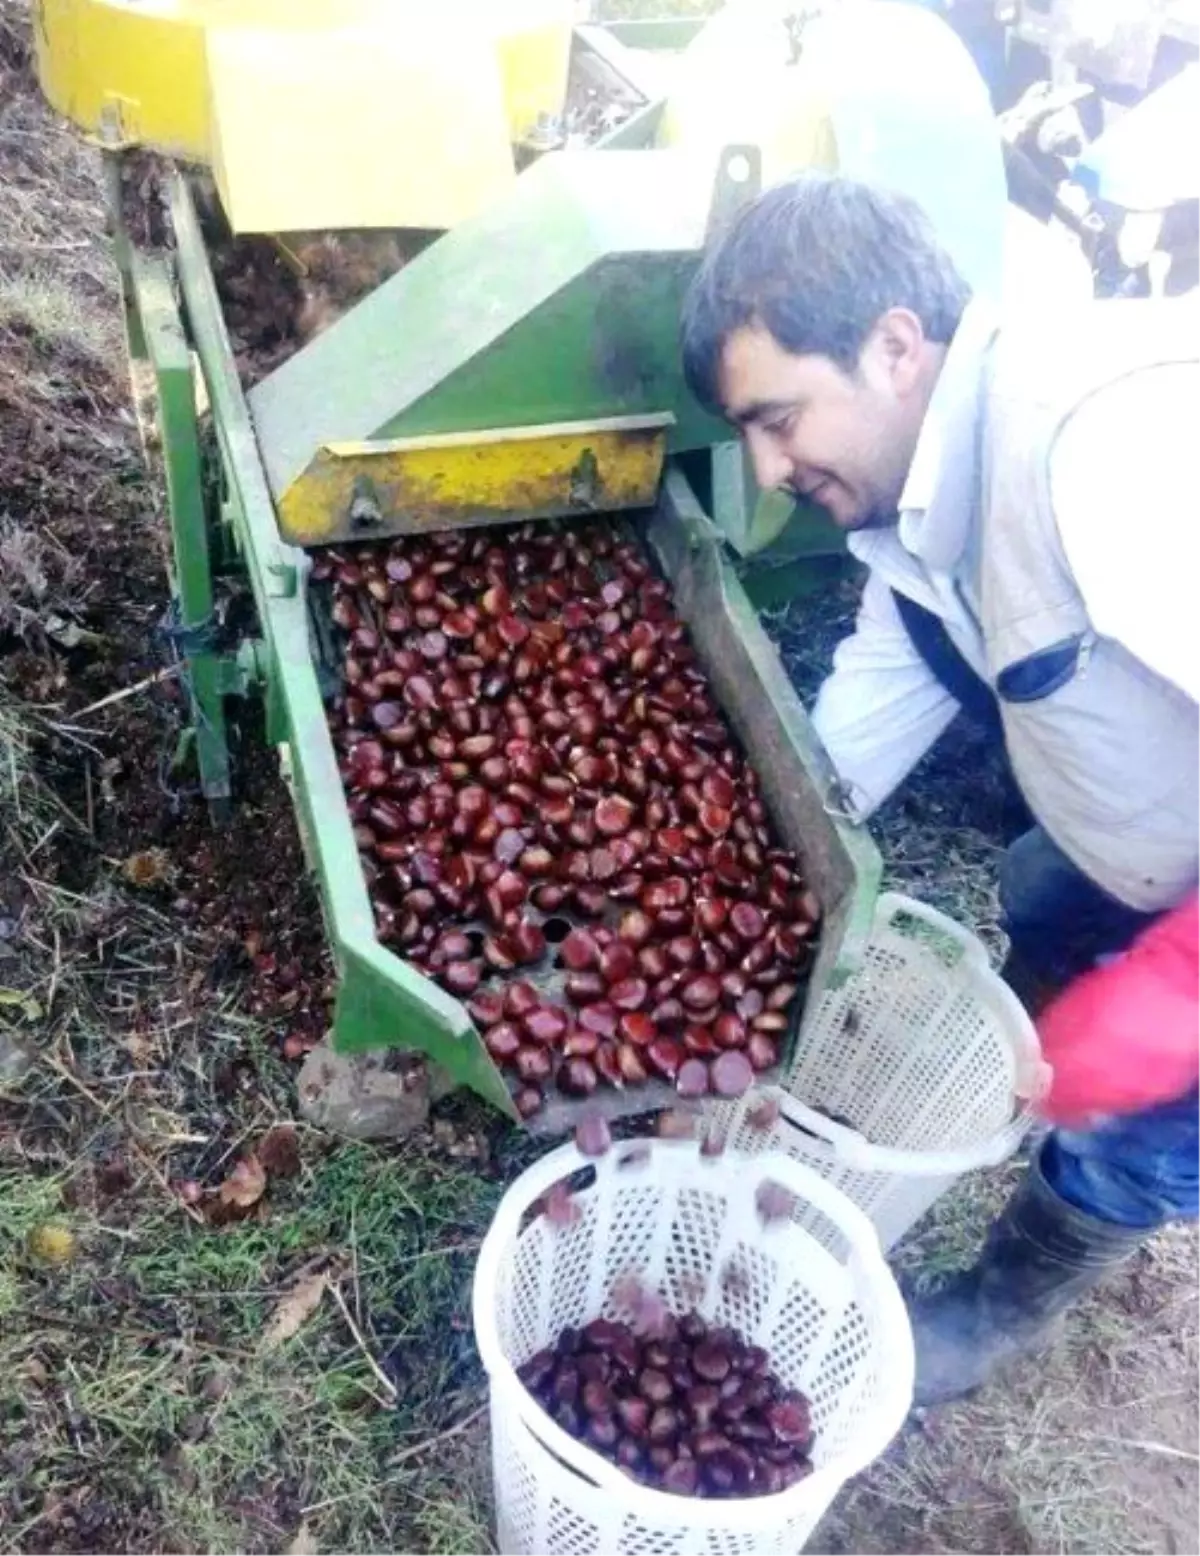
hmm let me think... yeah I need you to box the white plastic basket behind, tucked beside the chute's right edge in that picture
[711,892,1046,1249]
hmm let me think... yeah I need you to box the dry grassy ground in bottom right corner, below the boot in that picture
[828,1232,1200,1556]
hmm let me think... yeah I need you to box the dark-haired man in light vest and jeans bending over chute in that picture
[683,174,1200,1402]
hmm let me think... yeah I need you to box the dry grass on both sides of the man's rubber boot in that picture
[812,1162,1200,1556]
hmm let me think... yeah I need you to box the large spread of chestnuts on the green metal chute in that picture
[313,520,820,1117]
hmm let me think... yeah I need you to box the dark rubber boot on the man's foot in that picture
[909,1164,1149,1405]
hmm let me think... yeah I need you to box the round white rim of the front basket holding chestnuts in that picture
[472,1141,915,1531]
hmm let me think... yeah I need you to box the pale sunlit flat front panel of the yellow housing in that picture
[209,17,515,232]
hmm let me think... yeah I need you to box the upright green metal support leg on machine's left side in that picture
[134,255,230,817]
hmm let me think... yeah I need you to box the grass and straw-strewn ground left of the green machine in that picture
[0,18,500,1531]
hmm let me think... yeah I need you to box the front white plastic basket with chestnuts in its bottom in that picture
[473,1141,914,1556]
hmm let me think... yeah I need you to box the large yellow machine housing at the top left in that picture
[36,0,574,232]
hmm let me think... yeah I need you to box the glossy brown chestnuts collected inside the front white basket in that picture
[517,1312,812,1497]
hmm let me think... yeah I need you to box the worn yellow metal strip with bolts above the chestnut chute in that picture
[279,415,672,546]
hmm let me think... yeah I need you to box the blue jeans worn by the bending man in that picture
[999,826,1200,1231]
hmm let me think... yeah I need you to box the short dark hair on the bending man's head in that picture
[682,173,970,409]
